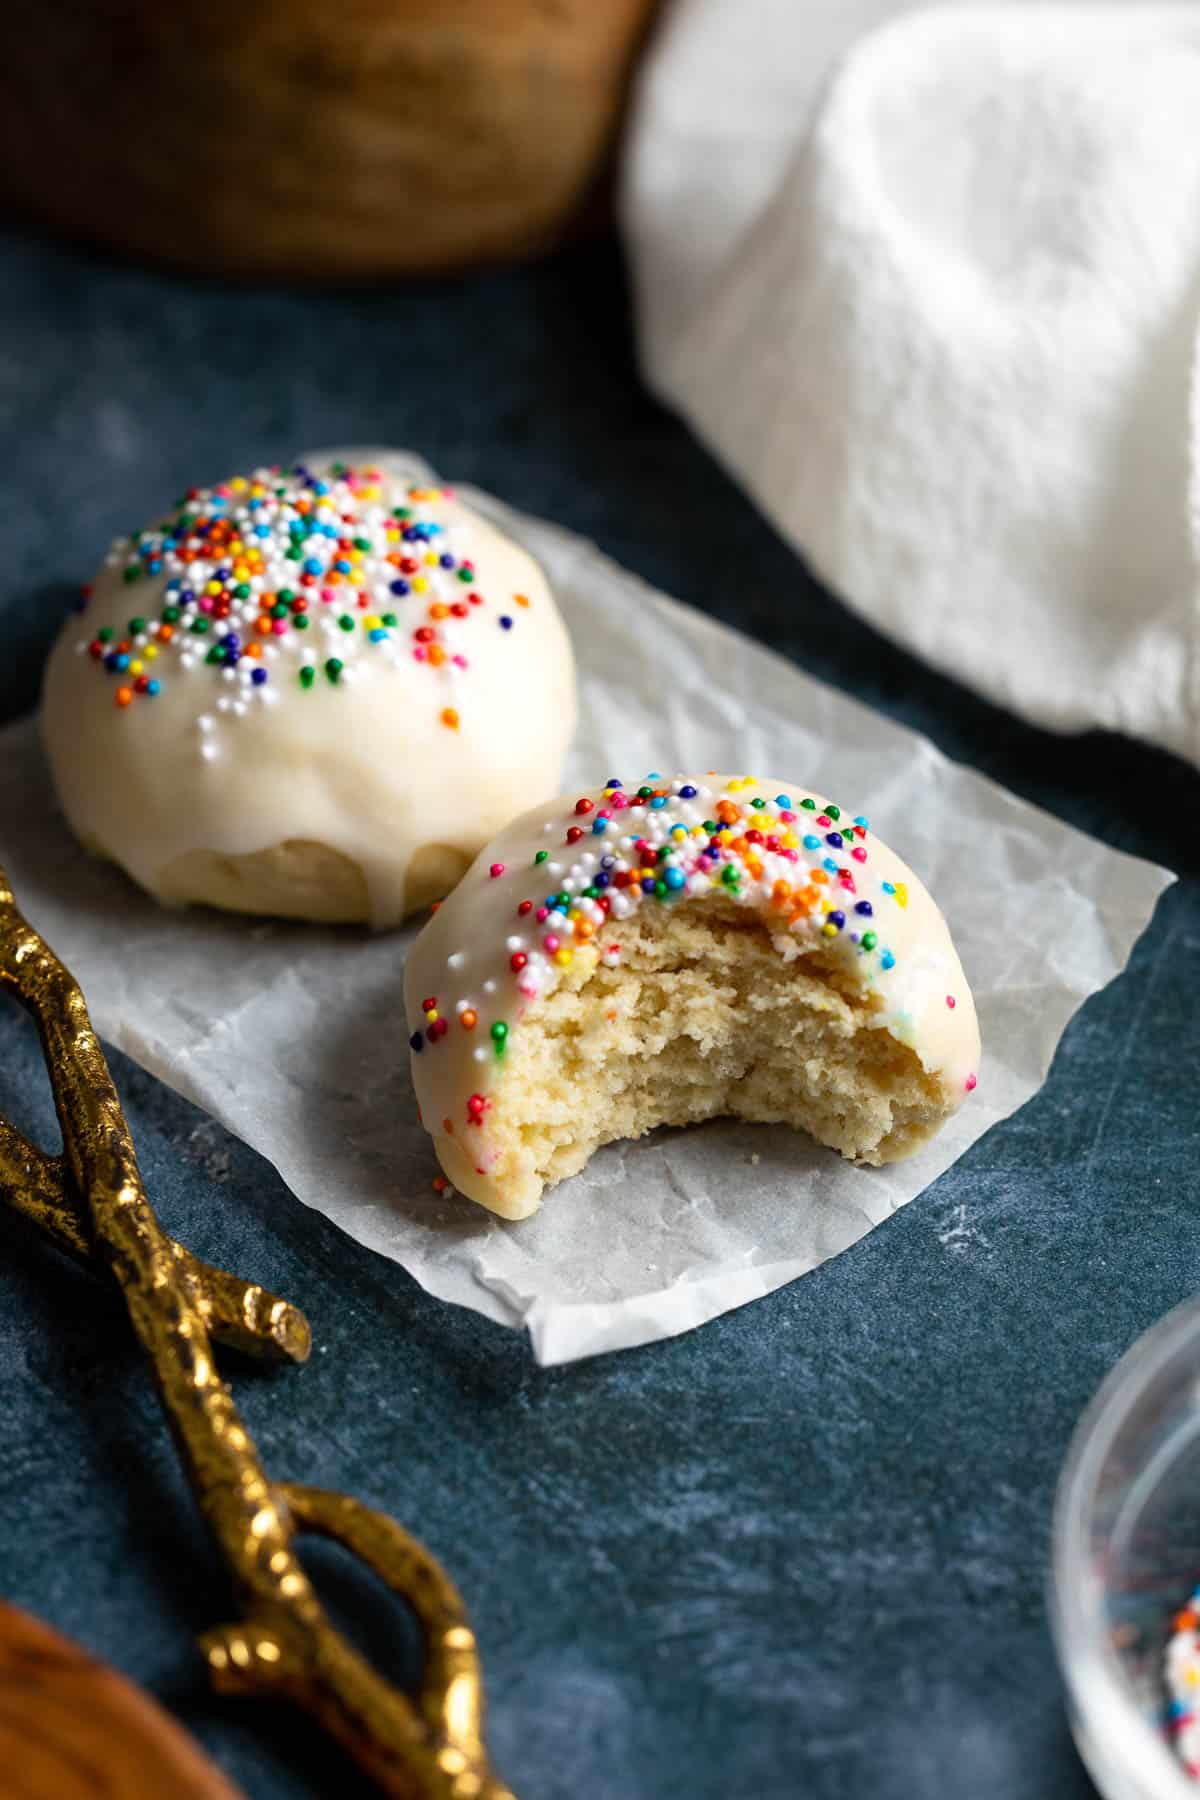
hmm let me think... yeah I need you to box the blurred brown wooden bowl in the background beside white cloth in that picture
[0,0,653,279]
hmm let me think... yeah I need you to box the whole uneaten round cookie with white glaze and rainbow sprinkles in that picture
[43,463,576,927]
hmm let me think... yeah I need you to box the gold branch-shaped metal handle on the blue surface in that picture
[0,868,511,1800]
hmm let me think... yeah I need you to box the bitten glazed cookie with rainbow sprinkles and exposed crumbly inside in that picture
[405,774,979,1219]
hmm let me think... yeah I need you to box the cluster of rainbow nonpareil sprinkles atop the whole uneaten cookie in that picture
[81,463,529,733]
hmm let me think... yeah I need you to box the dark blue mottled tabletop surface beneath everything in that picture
[0,228,1200,1800]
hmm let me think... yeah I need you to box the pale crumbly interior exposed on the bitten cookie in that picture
[488,898,952,1211]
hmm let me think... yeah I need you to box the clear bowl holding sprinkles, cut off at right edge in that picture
[1051,1301,1200,1800]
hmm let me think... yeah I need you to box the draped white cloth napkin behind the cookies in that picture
[622,0,1200,760]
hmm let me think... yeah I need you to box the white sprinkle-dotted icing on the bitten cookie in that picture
[405,774,979,1217]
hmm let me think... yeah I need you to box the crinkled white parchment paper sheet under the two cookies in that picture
[0,455,1171,1363]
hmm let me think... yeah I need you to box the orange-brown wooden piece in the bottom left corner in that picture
[0,1602,243,1800]
